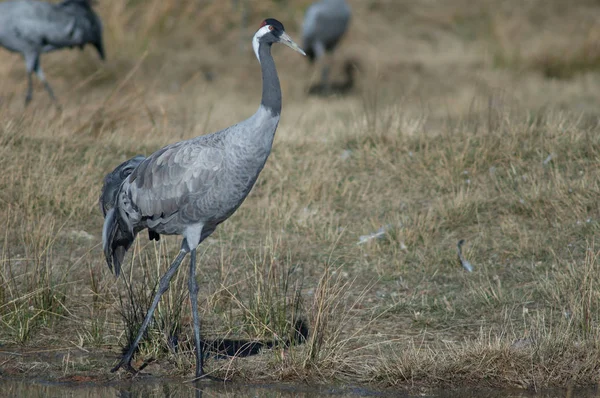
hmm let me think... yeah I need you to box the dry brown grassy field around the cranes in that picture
[0,0,600,389]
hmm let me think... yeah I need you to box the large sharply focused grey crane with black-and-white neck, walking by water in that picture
[102,19,306,377]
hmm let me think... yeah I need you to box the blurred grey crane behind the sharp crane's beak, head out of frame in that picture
[302,0,351,84]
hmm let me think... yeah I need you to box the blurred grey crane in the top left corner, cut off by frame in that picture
[0,0,104,105]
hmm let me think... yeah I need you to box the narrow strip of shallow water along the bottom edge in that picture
[0,379,600,398]
